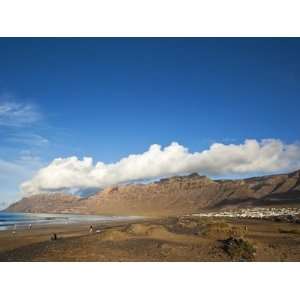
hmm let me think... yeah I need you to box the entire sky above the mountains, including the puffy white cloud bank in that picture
[0,38,300,208]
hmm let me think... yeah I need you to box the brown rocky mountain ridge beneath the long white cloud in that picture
[7,170,300,215]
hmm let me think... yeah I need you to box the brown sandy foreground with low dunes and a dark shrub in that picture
[0,217,300,261]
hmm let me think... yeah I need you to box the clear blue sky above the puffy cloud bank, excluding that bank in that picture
[0,38,300,205]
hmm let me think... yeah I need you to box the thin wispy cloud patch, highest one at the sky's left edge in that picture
[0,99,41,127]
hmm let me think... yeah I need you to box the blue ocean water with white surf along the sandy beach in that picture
[0,212,140,230]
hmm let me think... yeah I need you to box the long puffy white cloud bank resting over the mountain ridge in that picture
[21,139,300,195]
